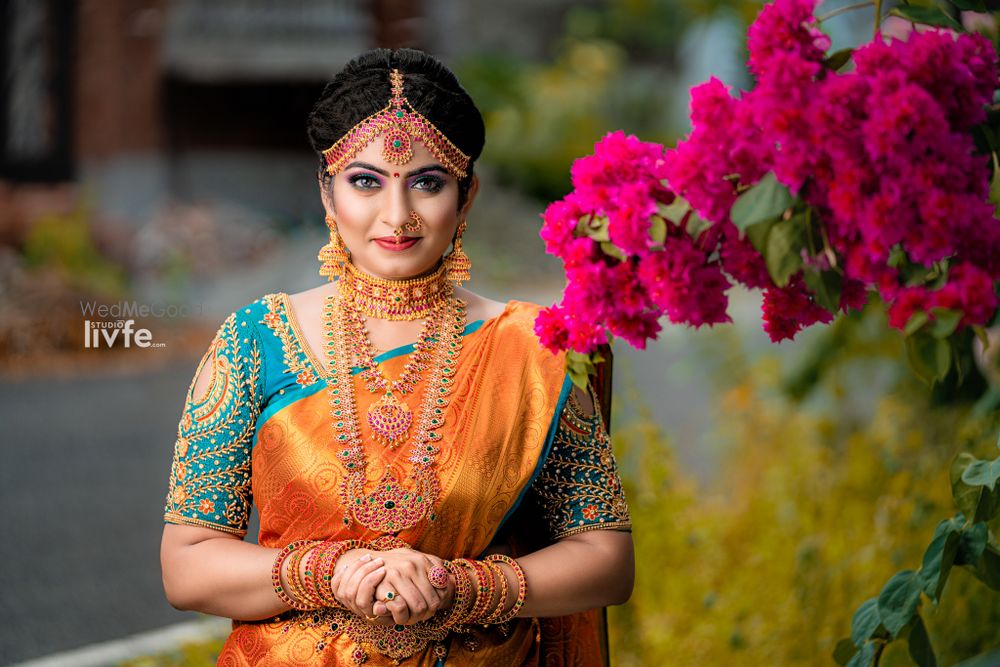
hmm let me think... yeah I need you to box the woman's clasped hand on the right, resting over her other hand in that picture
[372,549,455,625]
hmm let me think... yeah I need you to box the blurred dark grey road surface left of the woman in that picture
[0,364,229,665]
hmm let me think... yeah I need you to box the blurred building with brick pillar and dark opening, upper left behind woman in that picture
[0,0,436,243]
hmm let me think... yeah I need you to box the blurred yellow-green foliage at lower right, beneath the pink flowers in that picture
[610,306,1000,665]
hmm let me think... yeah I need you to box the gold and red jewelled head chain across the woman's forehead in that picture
[323,69,470,178]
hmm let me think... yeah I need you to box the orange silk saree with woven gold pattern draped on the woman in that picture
[218,294,606,667]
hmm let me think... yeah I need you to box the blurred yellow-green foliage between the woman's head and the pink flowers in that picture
[456,0,761,201]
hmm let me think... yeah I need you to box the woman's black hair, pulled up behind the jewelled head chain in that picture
[307,49,486,207]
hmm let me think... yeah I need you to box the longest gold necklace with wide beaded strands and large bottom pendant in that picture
[323,296,466,534]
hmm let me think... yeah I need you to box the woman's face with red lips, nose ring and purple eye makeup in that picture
[323,137,475,279]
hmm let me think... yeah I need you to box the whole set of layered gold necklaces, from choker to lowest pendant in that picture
[323,269,466,534]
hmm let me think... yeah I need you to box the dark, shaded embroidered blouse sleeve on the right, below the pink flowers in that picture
[532,380,632,540]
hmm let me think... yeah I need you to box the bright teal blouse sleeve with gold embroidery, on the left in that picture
[163,311,264,537]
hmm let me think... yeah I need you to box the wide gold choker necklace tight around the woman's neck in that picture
[338,263,454,321]
